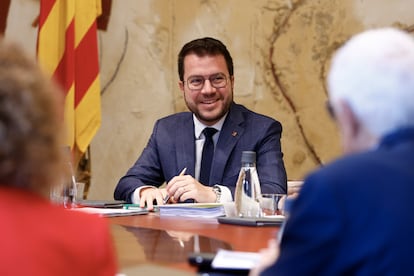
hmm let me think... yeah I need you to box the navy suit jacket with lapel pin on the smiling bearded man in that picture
[114,103,286,201]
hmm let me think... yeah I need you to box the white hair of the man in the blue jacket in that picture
[327,28,414,137]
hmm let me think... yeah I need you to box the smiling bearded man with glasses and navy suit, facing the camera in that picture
[114,37,286,209]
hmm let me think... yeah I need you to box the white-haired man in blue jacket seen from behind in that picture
[251,28,414,275]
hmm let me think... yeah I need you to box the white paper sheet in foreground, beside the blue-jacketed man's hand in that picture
[211,249,260,270]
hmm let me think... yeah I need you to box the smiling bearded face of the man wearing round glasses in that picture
[179,54,234,125]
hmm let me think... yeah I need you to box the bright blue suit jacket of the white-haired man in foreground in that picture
[264,129,414,275]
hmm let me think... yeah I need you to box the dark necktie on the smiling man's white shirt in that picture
[199,127,217,186]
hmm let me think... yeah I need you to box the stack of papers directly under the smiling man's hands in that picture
[158,203,225,218]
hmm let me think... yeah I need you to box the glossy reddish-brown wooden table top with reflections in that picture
[108,213,279,272]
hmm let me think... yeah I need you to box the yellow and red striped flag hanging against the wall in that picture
[37,0,101,152]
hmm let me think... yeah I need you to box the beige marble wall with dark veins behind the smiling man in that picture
[6,0,414,198]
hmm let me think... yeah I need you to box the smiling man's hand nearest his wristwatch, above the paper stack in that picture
[167,175,216,203]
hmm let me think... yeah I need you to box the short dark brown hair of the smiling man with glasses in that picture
[178,37,233,81]
